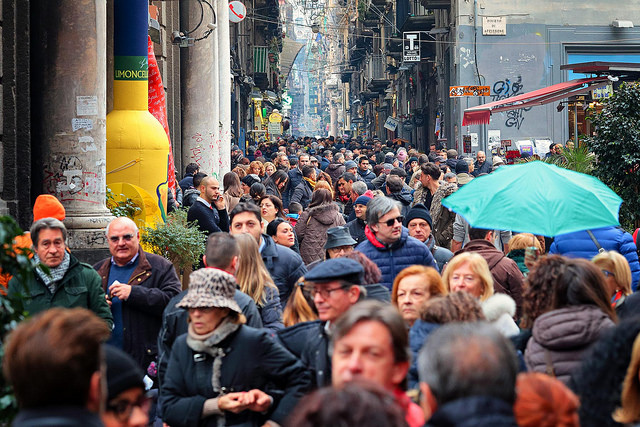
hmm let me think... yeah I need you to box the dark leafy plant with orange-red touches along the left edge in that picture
[0,216,35,424]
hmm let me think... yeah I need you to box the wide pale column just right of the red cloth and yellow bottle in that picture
[180,1,219,175]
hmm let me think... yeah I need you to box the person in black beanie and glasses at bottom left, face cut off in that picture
[102,345,151,427]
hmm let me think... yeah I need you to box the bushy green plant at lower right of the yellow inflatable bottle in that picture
[142,209,206,269]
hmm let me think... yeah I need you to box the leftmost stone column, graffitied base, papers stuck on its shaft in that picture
[38,0,111,259]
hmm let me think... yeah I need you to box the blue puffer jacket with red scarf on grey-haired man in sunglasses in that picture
[356,226,439,290]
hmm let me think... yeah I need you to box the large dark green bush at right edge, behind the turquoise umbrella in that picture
[585,82,640,228]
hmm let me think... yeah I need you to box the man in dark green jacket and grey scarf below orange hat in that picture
[9,218,113,329]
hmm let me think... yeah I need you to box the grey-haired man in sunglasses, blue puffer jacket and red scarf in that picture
[356,196,439,290]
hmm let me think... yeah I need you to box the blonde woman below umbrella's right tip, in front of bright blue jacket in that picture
[591,251,640,319]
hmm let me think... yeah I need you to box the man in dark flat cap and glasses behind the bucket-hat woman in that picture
[278,258,364,388]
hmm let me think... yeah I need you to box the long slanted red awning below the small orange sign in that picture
[462,77,608,126]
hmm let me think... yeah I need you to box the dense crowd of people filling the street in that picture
[3,137,640,427]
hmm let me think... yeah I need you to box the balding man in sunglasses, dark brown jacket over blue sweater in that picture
[93,217,181,371]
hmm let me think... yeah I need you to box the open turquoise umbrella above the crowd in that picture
[442,161,622,236]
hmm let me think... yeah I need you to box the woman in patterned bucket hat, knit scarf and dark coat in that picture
[160,268,309,427]
